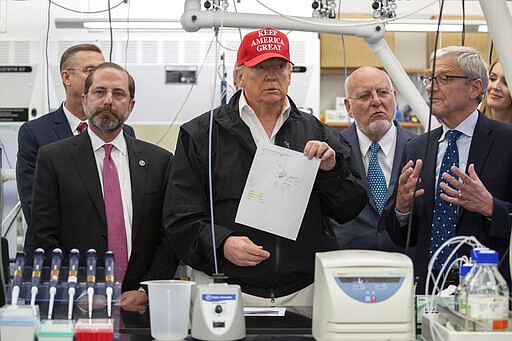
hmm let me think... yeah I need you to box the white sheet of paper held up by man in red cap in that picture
[235,144,320,240]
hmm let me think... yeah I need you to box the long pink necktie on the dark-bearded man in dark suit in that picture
[103,143,128,282]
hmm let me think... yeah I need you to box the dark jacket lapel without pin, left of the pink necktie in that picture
[72,133,107,227]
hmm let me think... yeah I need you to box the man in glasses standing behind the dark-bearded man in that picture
[16,44,135,262]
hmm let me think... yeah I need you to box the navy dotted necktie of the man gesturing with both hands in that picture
[430,130,461,269]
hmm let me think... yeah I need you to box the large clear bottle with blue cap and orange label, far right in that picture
[467,250,508,331]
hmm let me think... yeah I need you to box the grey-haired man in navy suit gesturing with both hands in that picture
[386,46,512,293]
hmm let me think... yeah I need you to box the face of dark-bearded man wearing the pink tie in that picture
[82,68,134,133]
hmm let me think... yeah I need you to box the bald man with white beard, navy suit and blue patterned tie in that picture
[331,66,416,252]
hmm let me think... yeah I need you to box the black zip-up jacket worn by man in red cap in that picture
[164,91,368,297]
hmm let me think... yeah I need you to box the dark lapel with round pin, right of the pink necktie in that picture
[124,134,148,241]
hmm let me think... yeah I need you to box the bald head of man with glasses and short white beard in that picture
[345,67,396,141]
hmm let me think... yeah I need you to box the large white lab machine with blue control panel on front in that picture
[312,250,415,340]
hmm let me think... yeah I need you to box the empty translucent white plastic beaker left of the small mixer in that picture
[142,280,195,340]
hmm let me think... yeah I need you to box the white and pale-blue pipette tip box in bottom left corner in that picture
[0,305,39,341]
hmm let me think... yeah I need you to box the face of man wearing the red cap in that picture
[240,58,291,106]
